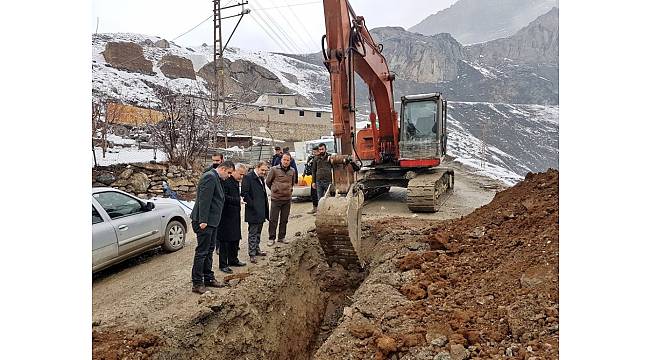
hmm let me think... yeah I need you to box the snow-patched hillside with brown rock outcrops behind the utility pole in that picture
[92,33,327,106]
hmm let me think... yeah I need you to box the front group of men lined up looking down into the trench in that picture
[191,148,316,294]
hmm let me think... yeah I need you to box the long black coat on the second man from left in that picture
[217,177,241,242]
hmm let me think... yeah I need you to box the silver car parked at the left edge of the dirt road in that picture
[92,187,191,273]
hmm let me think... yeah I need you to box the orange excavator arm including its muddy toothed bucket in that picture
[315,0,399,268]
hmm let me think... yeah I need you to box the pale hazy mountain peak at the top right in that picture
[409,0,558,45]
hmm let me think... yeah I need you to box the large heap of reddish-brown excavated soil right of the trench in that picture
[316,170,559,359]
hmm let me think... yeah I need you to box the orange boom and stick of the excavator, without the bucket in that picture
[323,0,399,170]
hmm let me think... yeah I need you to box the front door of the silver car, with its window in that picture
[93,191,161,256]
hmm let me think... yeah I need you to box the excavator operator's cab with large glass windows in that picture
[399,93,447,167]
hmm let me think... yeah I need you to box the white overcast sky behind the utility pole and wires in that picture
[91,0,456,53]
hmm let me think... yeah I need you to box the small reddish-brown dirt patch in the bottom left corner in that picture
[93,329,164,360]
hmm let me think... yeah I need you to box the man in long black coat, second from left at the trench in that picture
[217,164,248,274]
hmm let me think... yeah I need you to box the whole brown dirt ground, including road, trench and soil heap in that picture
[93,165,558,359]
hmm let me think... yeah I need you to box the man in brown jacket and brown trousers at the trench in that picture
[266,154,296,246]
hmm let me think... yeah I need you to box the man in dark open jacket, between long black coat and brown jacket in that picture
[241,161,269,263]
